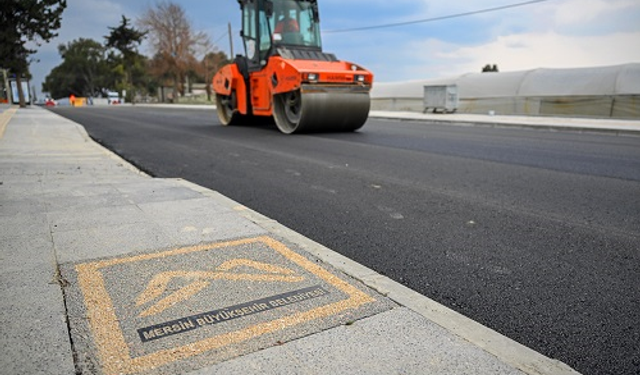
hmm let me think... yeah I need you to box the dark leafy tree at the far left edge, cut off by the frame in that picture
[0,0,67,107]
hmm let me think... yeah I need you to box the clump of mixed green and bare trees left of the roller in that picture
[43,2,230,102]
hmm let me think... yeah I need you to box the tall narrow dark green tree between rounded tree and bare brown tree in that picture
[104,15,146,102]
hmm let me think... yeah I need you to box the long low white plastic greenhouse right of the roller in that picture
[371,63,640,118]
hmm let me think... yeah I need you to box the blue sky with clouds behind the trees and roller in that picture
[31,0,640,97]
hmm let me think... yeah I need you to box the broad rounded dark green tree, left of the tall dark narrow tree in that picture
[42,38,109,98]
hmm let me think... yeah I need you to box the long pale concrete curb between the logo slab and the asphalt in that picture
[170,179,579,375]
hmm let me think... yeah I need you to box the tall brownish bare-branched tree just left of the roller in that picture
[138,1,210,100]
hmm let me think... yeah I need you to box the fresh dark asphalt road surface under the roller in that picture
[50,107,640,375]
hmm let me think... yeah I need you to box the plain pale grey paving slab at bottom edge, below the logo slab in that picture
[189,308,524,375]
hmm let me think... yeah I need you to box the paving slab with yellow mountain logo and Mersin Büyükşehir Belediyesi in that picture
[61,236,395,374]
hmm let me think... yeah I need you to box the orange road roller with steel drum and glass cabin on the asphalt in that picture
[213,0,373,134]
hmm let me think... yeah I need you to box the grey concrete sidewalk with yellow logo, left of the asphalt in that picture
[0,107,576,375]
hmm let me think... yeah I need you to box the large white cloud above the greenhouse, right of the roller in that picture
[356,0,640,81]
